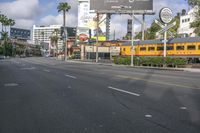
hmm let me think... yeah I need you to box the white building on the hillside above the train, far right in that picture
[178,7,197,37]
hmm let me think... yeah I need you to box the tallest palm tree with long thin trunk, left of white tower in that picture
[57,2,71,60]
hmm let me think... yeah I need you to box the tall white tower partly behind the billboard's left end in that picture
[78,0,106,38]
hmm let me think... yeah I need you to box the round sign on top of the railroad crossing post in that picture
[159,7,173,24]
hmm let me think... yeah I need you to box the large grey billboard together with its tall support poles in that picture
[90,0,154,63]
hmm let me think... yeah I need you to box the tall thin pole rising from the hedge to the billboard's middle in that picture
[131,10,135,66]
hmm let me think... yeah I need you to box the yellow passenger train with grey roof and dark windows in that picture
[121,37,200,58]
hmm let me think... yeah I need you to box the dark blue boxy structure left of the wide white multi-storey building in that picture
[9,27,31,42]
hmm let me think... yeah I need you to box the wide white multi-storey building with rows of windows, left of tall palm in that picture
[33,25,63,50]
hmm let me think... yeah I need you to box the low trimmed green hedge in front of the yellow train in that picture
[114,57,187,67]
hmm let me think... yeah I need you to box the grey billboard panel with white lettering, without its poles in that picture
[90,0,153,11]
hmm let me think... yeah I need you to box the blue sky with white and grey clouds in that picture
[0,0,188,38]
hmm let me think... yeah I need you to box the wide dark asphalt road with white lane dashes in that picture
[0,58,200,133]
